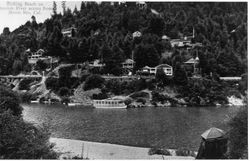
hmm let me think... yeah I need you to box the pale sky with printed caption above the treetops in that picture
[0,0,81,33]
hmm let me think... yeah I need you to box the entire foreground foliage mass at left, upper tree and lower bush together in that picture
[0,87,57,159]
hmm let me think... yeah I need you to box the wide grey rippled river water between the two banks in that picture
[22,104,237,151]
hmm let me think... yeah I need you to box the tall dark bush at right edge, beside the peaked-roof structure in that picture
[228,106,248,159]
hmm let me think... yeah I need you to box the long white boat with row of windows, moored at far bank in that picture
[93,99,127,109]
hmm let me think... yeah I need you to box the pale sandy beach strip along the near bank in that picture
[50,138,194,160]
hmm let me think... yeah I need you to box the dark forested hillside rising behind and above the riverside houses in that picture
[0,2,247,76]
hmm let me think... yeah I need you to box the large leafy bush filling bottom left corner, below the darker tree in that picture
[0,112,58,159]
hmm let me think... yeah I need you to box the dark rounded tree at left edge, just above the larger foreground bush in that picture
[0,86,23,116]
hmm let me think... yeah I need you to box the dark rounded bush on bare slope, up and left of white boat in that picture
[84,74,105,90]
